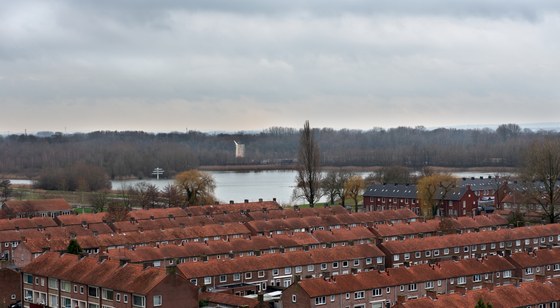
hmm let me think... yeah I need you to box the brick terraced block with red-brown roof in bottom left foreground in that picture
[22,252,198,308]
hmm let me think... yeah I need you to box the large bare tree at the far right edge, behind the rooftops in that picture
[523,139,560,223]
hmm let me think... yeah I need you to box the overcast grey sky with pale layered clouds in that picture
[0,0,560,133]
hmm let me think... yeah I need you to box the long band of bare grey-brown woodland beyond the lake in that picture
[0,124,560,178]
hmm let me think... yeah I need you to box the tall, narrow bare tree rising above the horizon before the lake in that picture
[293,121,322,207]
